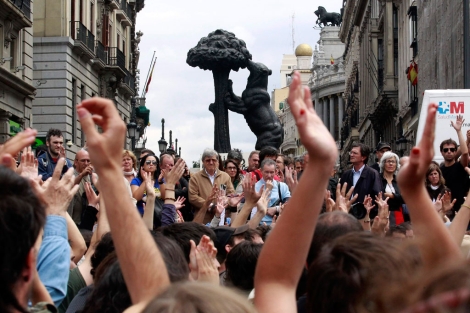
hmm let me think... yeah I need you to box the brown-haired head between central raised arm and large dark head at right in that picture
[307,211,364,265]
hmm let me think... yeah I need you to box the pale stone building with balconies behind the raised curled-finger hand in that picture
[33,0,149,157]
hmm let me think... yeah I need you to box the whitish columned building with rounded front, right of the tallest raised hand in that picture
[309,26,345,147]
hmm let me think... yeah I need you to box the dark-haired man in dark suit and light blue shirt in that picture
[341,143,382,219]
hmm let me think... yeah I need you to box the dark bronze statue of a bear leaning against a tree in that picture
[186,29,283,153]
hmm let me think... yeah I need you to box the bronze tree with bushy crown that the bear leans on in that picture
[186,29,251,153]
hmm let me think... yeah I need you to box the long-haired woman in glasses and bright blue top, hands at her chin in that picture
[131,154,162,215]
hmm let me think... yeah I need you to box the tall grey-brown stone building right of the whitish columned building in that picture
[339,0,417,168]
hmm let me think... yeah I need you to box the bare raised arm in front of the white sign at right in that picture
[398,104,461,267]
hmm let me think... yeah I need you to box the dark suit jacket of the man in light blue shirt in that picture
[341,165,382,219]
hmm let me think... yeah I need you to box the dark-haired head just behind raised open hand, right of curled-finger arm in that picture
[160,222,217,263]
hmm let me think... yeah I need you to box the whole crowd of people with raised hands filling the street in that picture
[0,73,470,313]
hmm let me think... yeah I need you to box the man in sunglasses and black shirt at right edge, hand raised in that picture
[440,115,468,219]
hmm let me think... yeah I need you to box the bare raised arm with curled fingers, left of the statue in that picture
[77,98,170,306]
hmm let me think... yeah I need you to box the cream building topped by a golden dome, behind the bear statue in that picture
[277,44,313,156]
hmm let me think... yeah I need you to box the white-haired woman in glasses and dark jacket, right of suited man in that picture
[378,151,409,226]
